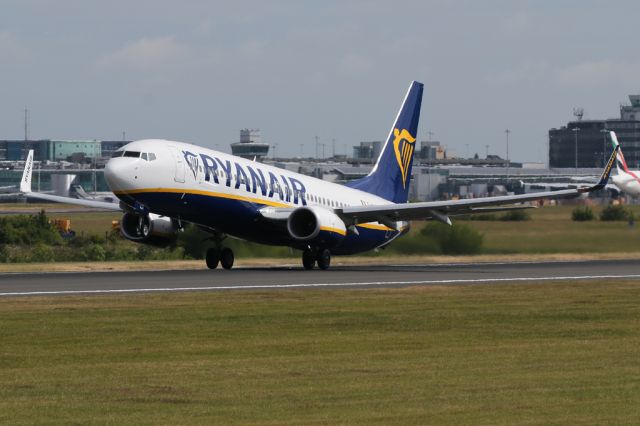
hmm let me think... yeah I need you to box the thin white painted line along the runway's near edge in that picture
[0,274,640,296]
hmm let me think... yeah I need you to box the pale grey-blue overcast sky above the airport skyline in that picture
[0,0,640,161]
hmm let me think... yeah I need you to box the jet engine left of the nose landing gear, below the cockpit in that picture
[120,213,180,246]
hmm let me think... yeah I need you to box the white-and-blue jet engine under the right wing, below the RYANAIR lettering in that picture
[287,206,347,247]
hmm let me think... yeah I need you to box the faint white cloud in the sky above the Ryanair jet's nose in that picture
[98,36,190,71]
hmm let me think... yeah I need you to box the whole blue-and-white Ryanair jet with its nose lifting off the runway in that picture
[20,81,615,269]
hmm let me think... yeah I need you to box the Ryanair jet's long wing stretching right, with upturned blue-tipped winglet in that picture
[335,147,619,225]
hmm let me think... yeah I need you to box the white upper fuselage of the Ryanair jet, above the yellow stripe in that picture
[105,139,392,209]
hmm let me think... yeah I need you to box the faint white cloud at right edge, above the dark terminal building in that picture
[555,59,640,87]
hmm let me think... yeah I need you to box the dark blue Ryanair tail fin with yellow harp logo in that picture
[347,81,423,203]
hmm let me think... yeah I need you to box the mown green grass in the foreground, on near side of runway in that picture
[0,281,640,424]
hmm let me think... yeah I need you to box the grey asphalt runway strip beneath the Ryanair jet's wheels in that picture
[0,260,640,297]
